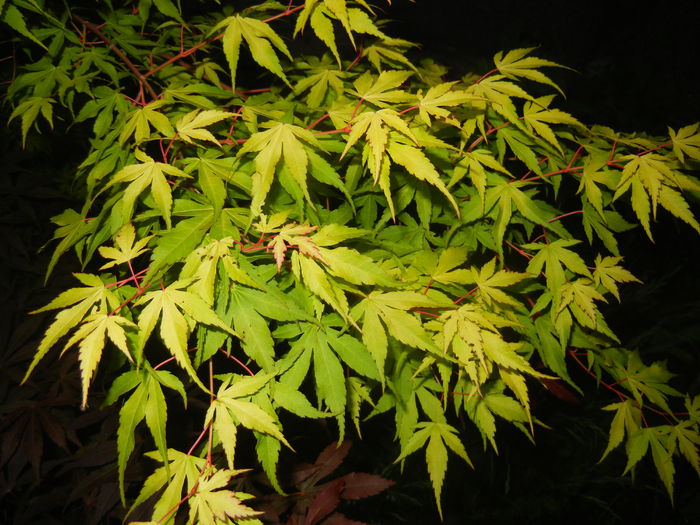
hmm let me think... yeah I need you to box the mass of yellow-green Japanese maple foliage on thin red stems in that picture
[0,0,700,524]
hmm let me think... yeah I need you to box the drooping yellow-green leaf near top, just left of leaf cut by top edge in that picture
[212,15,292,91]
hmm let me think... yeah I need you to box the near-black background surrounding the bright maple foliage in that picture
[0,0,700,525]
